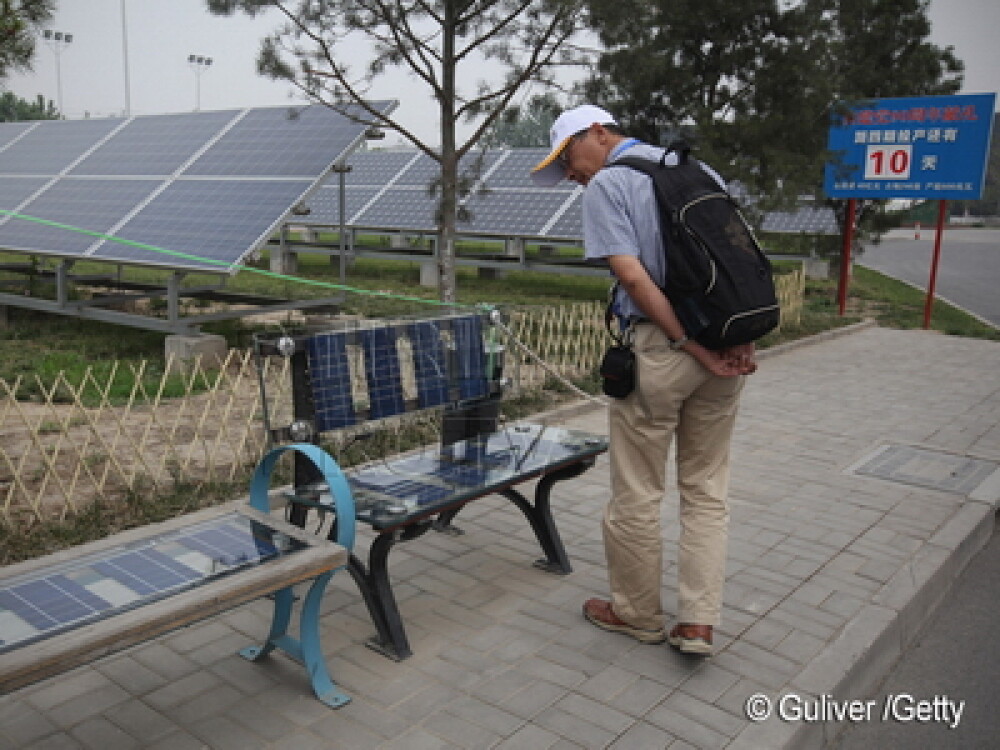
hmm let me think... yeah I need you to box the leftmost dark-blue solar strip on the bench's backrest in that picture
[306,333,357,432]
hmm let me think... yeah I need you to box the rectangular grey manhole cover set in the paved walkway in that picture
[852,445,997,495]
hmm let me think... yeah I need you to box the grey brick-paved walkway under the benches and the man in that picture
[0,328,1000,750]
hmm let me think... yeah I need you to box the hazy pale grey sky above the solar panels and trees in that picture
[1,0,1000,148]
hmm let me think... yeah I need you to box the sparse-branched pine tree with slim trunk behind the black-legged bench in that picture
[206,0,583,302]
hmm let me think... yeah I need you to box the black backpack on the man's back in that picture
[610,144,780,349]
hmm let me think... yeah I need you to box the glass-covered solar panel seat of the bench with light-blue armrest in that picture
[0,513,305,653]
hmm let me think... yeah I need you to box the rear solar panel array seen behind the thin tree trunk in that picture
[304,148,583,239]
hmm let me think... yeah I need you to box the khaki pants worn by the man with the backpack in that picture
[604,323,744,630]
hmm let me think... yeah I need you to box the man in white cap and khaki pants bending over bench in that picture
[532,105,756,654]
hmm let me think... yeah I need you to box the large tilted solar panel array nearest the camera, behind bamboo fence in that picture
[0,102,394,271]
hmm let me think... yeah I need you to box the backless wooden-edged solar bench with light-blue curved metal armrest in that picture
[0,445,354,708]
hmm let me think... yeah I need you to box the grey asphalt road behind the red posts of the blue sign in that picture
[858,227,1000,326]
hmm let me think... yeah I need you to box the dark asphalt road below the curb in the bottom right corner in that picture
[832,520,1000,750]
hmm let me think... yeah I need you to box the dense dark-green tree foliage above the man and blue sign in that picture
[587,0,962,214]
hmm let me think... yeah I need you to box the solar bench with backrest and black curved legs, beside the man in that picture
[255,312,607,660]
